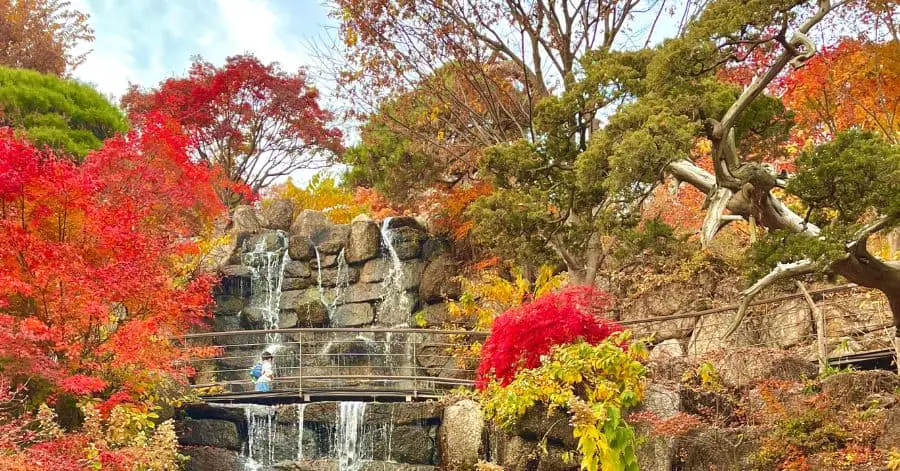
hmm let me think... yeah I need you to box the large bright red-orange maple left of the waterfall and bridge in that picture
[0,116,224,400]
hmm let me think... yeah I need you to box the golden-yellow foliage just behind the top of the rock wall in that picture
[262,173,370,224]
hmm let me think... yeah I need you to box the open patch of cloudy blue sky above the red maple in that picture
[72,0,334,98]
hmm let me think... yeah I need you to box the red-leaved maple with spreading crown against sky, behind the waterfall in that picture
[122,55,342,203]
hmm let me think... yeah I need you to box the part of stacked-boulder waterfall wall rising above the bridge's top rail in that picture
[215,206,460,330]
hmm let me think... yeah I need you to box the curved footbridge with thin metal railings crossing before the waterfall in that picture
[178,328,487,402]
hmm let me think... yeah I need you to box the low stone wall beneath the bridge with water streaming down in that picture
[177,401,483,471]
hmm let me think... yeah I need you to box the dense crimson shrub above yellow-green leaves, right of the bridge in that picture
[475,286,623,389]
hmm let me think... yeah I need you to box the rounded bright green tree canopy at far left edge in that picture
[0,67,128,160]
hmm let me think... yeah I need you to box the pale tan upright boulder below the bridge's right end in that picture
[439,399,484,471]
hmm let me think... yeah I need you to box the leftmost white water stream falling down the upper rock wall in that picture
[243,231,290,344]
